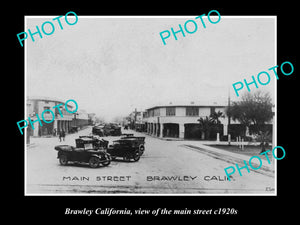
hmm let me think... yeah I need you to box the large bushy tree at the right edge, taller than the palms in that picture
[226,91,273,134]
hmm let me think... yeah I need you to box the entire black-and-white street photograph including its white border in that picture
[23,15,276,196]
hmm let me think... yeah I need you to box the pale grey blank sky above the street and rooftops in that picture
[25,14,277,120]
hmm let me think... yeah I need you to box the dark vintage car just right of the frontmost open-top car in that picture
[107,137,143,162]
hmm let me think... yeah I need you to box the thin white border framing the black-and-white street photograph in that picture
[24,15,278,196]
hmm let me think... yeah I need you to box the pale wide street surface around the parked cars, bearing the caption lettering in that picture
[26,127,275,195]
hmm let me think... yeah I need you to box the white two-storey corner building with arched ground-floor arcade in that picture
[143,102,228,139]
